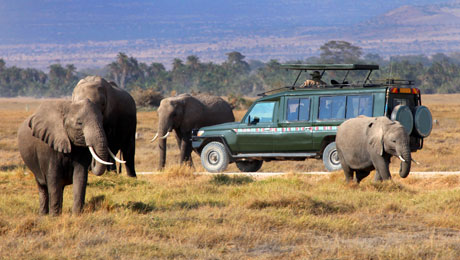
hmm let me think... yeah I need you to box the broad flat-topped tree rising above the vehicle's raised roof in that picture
[320,41,363,63]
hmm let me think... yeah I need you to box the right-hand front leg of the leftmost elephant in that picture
[72,165,88,215]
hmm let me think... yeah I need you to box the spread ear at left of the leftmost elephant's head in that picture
[28,101,72,153]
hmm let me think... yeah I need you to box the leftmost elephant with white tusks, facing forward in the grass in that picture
[18,99,118,215]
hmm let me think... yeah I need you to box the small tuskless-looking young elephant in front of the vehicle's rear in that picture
[335,116,413,183]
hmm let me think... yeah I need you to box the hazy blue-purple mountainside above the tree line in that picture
[0,0,460,68]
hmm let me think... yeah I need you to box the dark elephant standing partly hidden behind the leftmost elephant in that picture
[72,76,137,177]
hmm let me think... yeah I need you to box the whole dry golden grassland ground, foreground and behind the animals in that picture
[0,95,460,259]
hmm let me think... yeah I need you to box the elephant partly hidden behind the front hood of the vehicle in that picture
[152,94,235,169]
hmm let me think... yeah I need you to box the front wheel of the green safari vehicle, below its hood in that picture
[201,142,229,172]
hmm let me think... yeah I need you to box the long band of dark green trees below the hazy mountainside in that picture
[0,41,460,97]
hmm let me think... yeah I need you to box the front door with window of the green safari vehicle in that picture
[234,101,279,153]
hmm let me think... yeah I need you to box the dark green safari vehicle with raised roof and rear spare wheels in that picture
[192,64,432,172]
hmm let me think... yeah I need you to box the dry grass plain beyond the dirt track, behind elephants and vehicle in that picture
[0,94,460,172]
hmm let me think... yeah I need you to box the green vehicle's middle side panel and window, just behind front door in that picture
[273,97,312,152]
